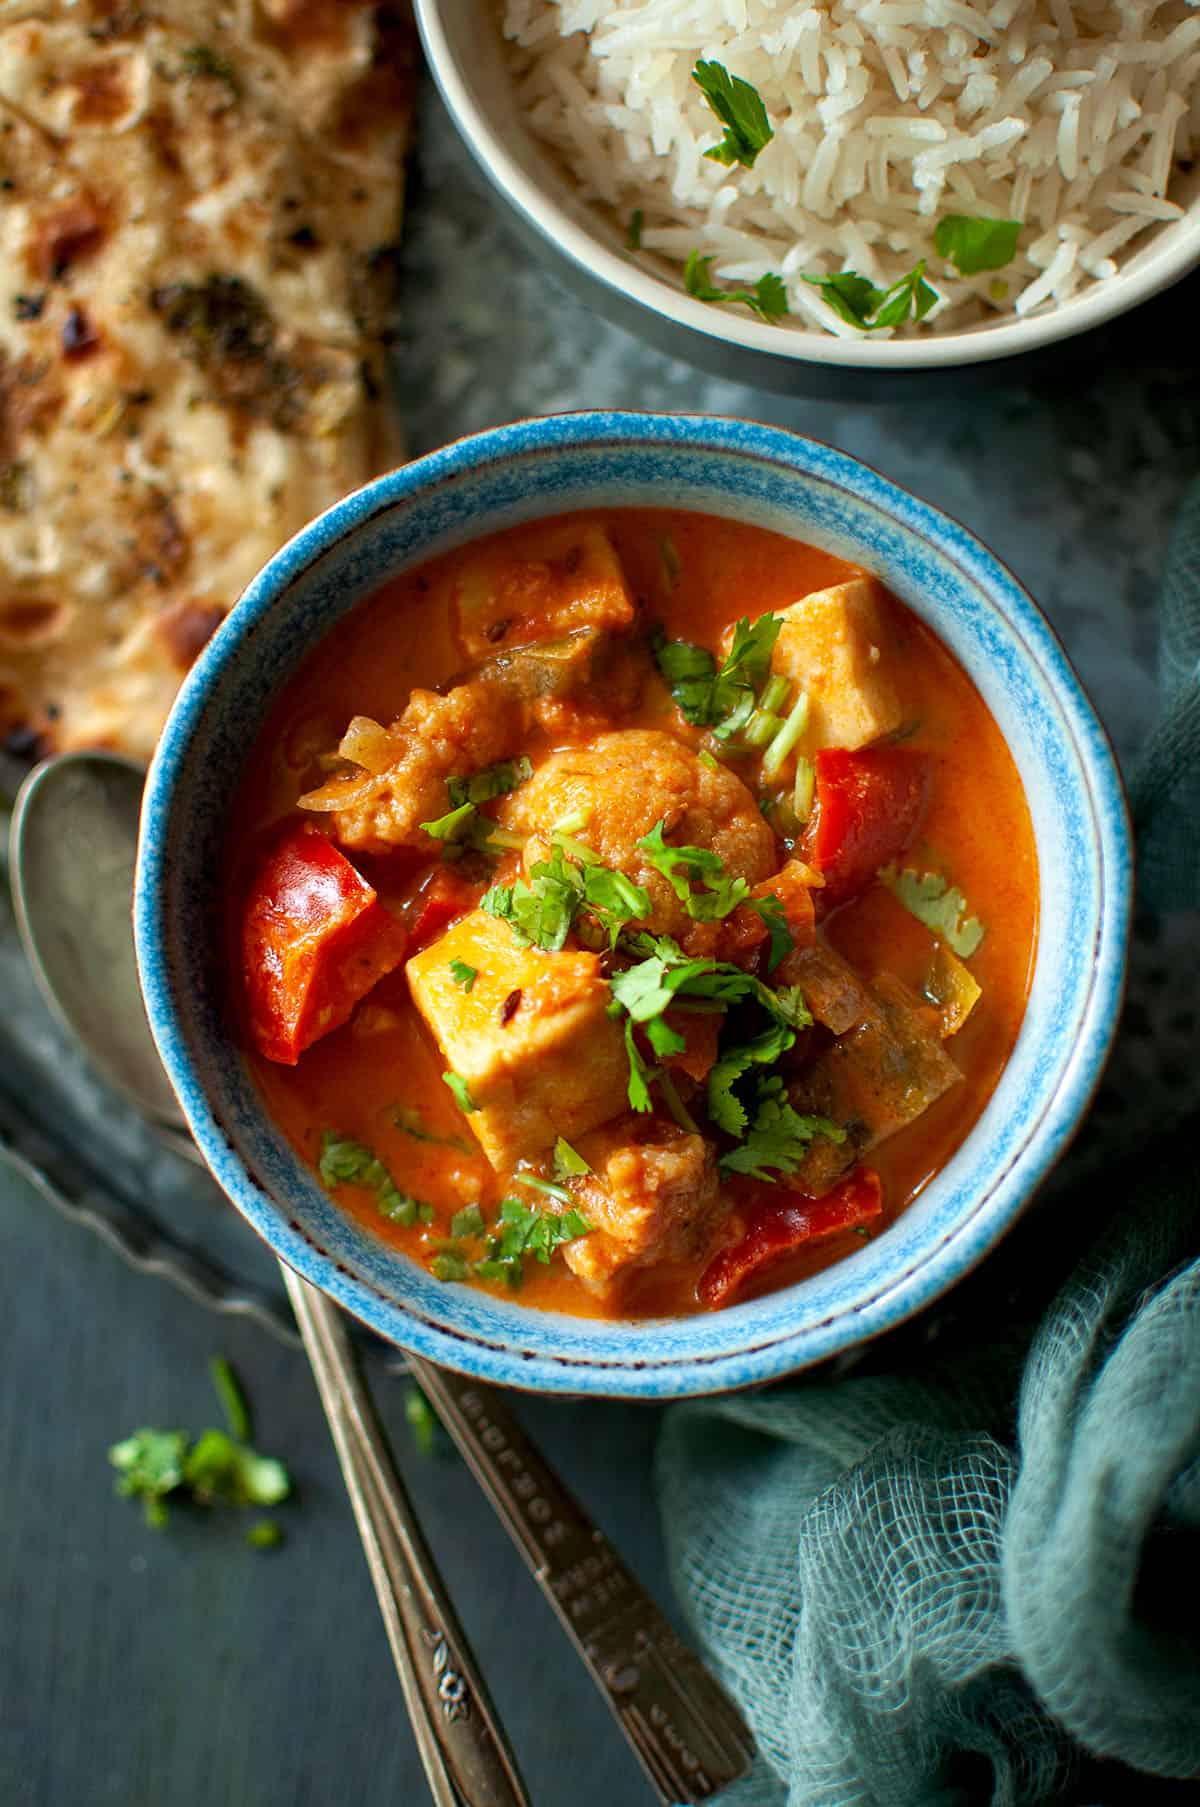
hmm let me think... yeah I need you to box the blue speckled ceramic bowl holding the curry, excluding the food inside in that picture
[134,414,1131,1399]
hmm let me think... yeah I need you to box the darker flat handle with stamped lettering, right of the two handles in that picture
[408,1353,754,1803]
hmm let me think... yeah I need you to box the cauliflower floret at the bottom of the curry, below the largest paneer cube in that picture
[562,1117,723,1297]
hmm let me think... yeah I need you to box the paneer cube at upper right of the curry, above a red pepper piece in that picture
[772,576,904,754]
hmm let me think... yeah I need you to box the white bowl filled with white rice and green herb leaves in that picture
[417,0,1200,387]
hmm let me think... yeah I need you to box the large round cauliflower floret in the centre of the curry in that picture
[499,728,777,954]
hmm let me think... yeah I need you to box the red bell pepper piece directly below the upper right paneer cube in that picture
[804,746,933,909]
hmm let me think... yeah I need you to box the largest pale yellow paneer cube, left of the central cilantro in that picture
[405,911,629,1173]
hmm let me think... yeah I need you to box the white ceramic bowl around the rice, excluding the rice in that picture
[416,0,1200,394]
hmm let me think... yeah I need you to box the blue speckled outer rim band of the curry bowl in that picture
[134,410,1133,1400]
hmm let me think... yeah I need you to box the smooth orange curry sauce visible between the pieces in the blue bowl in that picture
[230,510,1037,1317]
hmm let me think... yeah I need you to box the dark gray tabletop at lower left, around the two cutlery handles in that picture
[0,1173,661,1807]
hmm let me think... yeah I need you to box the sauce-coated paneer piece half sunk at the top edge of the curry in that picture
[454,520,634,660]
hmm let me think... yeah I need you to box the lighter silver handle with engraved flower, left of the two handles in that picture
[280,1261,530,1807]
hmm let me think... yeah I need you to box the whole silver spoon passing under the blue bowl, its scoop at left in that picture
[11,754,528,1807]
